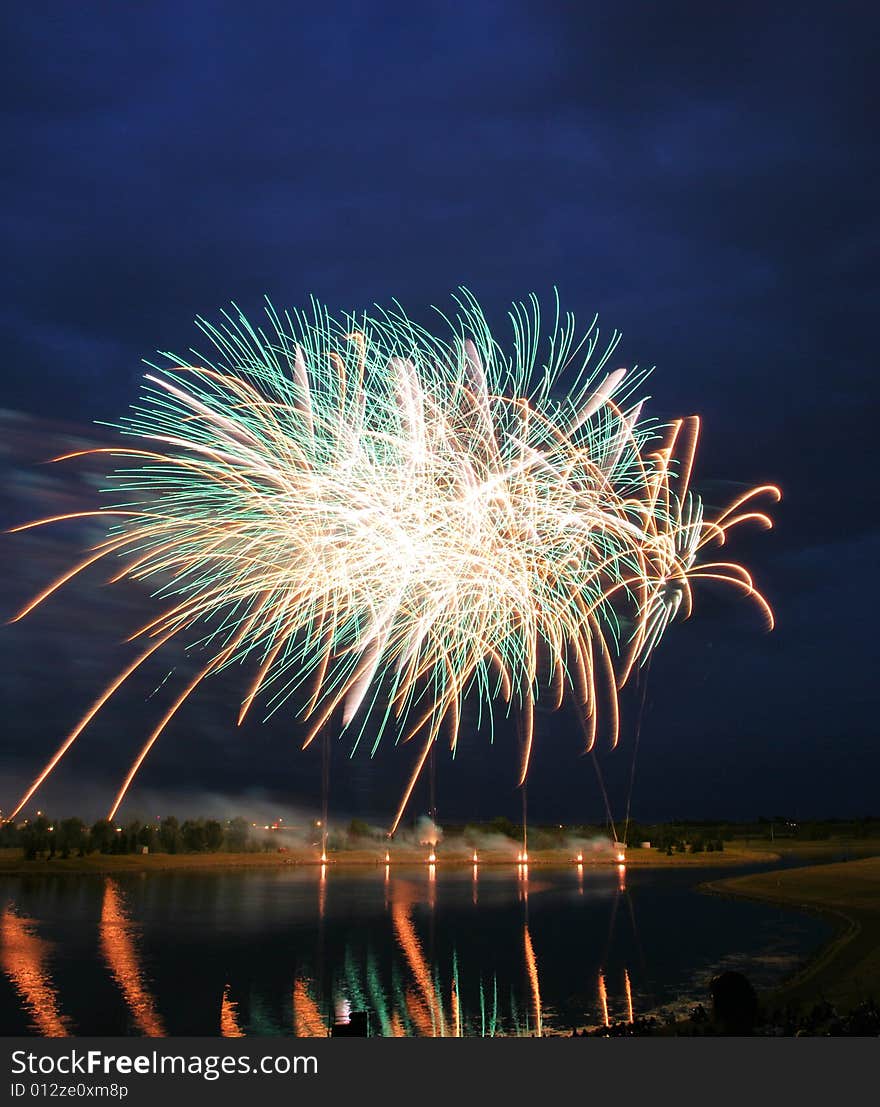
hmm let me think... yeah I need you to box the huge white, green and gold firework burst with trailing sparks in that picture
[6,293,778,827]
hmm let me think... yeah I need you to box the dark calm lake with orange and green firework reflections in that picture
[0,865,831,1036]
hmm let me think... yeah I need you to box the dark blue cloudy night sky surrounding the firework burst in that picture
[0,0,880,821]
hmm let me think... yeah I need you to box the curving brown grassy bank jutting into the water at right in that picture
[706,857,880,1011]
